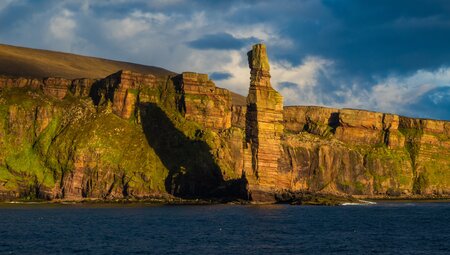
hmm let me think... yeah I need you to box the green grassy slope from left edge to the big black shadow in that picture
[0,89,167,198]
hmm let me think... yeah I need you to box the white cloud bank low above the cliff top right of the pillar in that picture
[280,65,450,114]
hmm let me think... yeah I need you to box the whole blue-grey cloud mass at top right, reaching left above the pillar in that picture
[218,0,450,76]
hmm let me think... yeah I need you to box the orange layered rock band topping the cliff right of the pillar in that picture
[284,106,404,149]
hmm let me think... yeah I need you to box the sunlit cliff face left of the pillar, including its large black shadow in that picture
[0,71,242,199]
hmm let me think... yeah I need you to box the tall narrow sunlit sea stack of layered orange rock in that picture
[244,44,288,201]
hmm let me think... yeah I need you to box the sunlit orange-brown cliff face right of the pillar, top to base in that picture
[284,106,450,195]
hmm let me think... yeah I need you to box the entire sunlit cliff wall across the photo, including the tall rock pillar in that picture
[0,45,450,201]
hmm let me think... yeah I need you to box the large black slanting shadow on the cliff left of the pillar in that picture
[139,103,246,198]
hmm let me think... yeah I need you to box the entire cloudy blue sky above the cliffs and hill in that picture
[0,0,450,120]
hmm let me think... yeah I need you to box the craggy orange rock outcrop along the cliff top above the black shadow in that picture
[92,71,231,131]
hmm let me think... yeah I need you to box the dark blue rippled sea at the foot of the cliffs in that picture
[0,202,450,254]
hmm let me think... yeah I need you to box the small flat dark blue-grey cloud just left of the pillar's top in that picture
[188,33,258,50]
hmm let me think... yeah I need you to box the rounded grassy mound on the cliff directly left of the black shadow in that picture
[45,110,167,191]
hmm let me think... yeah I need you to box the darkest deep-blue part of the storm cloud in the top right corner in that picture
[318,0,450,75]
